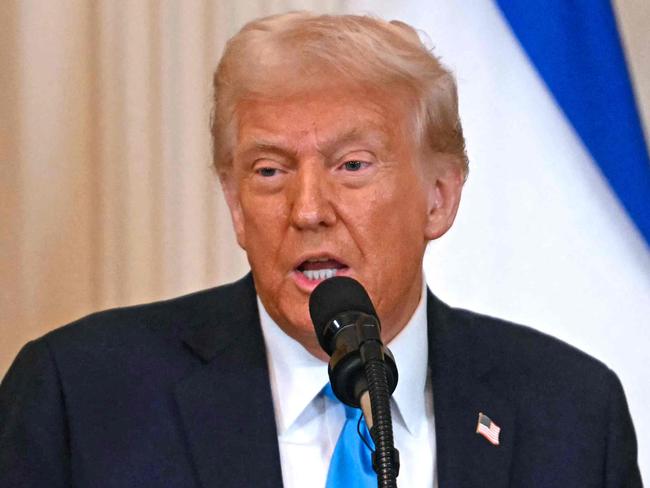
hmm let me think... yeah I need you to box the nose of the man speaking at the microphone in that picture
[291,164,336,230]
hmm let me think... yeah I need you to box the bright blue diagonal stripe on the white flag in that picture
[496,0,650,244]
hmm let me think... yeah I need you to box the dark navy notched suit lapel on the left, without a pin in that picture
[175,275,282,488]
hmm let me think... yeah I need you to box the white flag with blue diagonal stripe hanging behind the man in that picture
[351,0,650,479]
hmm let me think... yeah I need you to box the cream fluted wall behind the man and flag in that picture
[0,0,650,376]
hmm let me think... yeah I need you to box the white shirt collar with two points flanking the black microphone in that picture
[257,280,428,435]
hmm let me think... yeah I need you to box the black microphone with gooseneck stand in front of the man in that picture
[309,277,399,488]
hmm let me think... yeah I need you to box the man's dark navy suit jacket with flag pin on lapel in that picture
[0,275,641,488]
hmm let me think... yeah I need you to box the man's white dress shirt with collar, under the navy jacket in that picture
[257,285,437,488]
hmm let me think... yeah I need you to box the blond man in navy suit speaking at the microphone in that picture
[0,13,641,488]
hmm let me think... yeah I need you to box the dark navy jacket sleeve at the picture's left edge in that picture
[0,339,70,488]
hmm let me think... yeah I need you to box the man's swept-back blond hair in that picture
[211,12,468,174]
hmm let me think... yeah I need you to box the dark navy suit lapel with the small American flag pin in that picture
[428,294,515,488]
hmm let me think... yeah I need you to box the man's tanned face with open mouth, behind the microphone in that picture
[222,87,460,357]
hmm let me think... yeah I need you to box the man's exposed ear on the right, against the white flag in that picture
[425,157,465,241]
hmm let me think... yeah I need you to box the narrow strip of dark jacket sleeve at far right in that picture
[605,371,643,488]
